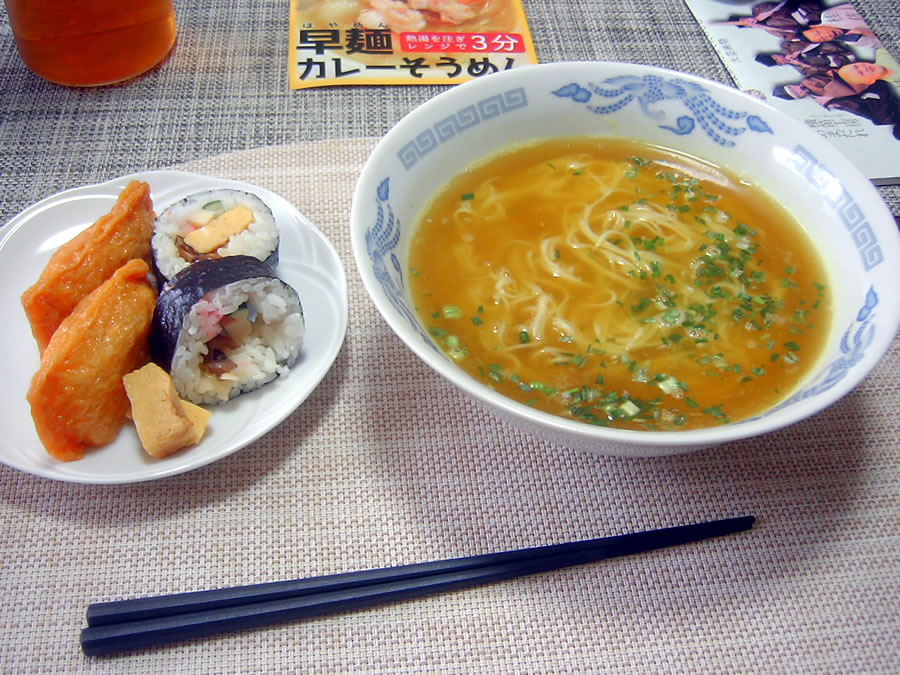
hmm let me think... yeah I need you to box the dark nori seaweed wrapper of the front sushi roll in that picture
[149,255,297,372]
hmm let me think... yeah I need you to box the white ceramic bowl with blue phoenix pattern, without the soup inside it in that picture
[350,62,900,456]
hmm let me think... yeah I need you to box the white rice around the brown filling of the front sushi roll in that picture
[171,277,305,404]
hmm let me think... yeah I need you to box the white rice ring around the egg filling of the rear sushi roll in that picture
[151,190,278,279]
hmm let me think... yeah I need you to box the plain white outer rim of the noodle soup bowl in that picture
[350,61,900,451]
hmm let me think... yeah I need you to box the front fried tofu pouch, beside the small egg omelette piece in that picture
[27,260,156,462]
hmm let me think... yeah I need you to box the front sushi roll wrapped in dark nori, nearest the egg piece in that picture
[150,255,305,404]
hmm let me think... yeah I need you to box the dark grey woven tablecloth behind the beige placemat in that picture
[0,0,900,223]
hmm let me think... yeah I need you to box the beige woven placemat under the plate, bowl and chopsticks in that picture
[0,138,900,673]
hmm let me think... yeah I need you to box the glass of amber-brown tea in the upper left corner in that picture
[4,0,175,87]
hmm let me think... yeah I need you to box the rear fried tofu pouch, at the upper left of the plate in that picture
[22,181,156,353]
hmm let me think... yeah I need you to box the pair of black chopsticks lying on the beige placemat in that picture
[81,516,754,656]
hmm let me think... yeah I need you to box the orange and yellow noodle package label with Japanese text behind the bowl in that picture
[289,0,537,89]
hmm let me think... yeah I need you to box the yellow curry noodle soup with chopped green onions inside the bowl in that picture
[409,138,831,430]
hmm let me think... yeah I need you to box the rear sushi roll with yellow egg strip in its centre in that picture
[151,189,278,282]
